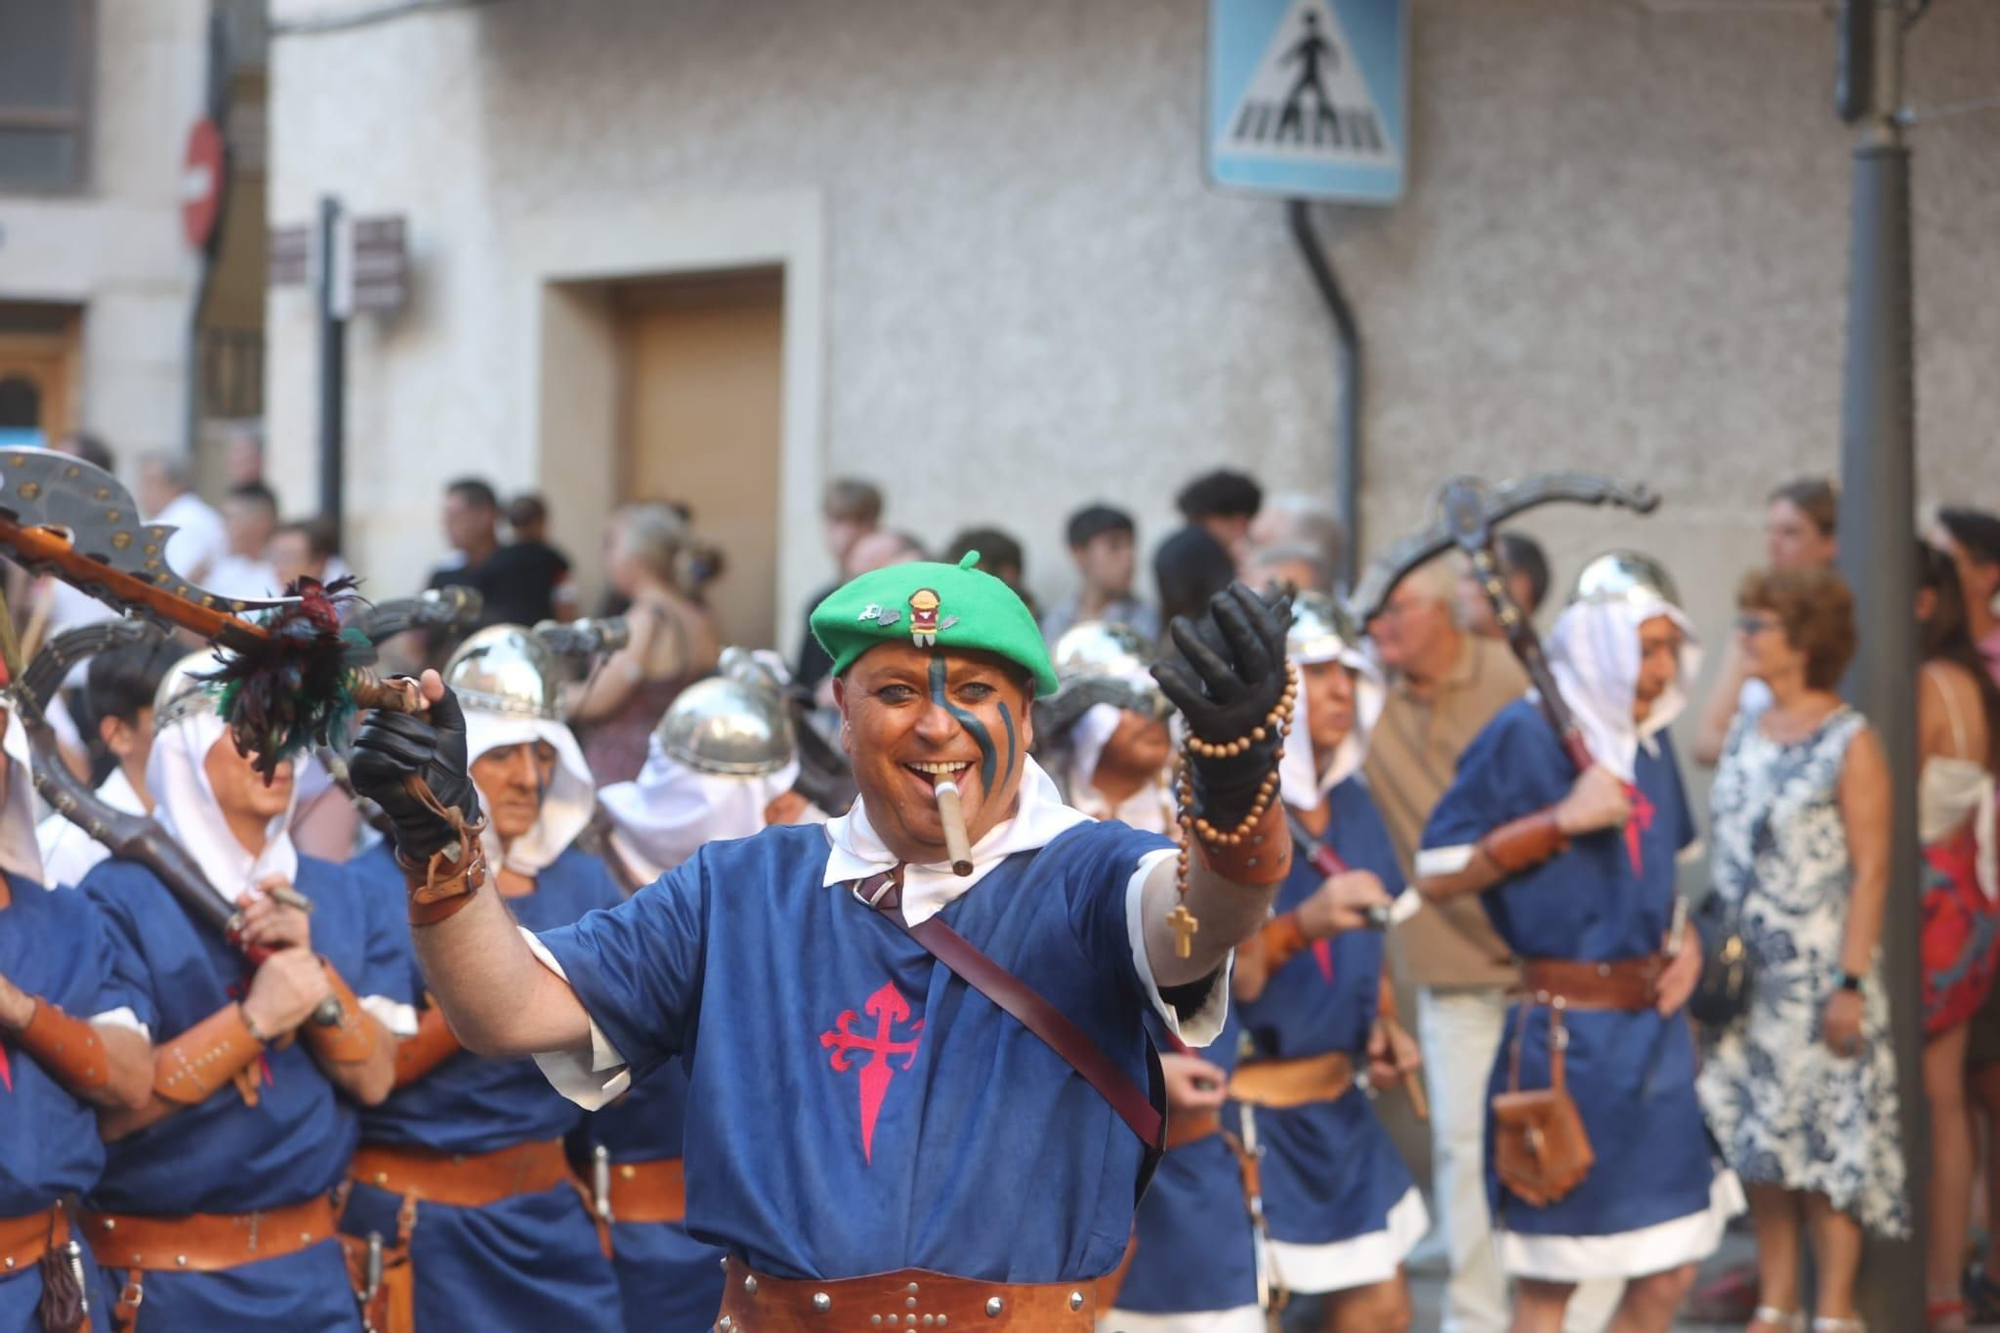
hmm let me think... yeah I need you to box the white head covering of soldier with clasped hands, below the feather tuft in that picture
[146,707,298,903]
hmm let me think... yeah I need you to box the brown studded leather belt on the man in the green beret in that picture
[716,1255,1098,1333]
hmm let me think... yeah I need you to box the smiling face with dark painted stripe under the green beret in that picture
[834,642,1034,865]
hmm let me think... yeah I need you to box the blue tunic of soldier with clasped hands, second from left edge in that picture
[82,857,410,1333]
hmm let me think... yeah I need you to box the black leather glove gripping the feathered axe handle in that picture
[348,689,480,865]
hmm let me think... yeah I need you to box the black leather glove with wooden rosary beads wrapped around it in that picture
[1152,582,1292,829]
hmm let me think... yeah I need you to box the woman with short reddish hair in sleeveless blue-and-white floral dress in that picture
[1700,568,1910,1333]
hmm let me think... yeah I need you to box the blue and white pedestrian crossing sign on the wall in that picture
[1204,0,1410,204]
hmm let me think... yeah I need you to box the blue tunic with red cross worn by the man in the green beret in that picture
[542,823,1170,1283]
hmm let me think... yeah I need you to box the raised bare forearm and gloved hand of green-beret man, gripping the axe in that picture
[352,671,590,1057]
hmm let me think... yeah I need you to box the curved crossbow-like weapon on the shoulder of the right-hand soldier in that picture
[1352,472,1660,773]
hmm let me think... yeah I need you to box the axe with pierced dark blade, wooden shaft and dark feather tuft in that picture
[0,448,420,779]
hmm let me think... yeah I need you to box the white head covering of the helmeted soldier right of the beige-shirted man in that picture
[1548,588,1702,783]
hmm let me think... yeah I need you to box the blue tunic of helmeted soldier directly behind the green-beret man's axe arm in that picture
[340,845,620,1333]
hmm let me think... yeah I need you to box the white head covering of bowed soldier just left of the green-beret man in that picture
[598,737,798,881]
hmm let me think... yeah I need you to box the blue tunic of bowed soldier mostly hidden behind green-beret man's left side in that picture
[576,1061,722,1333]
